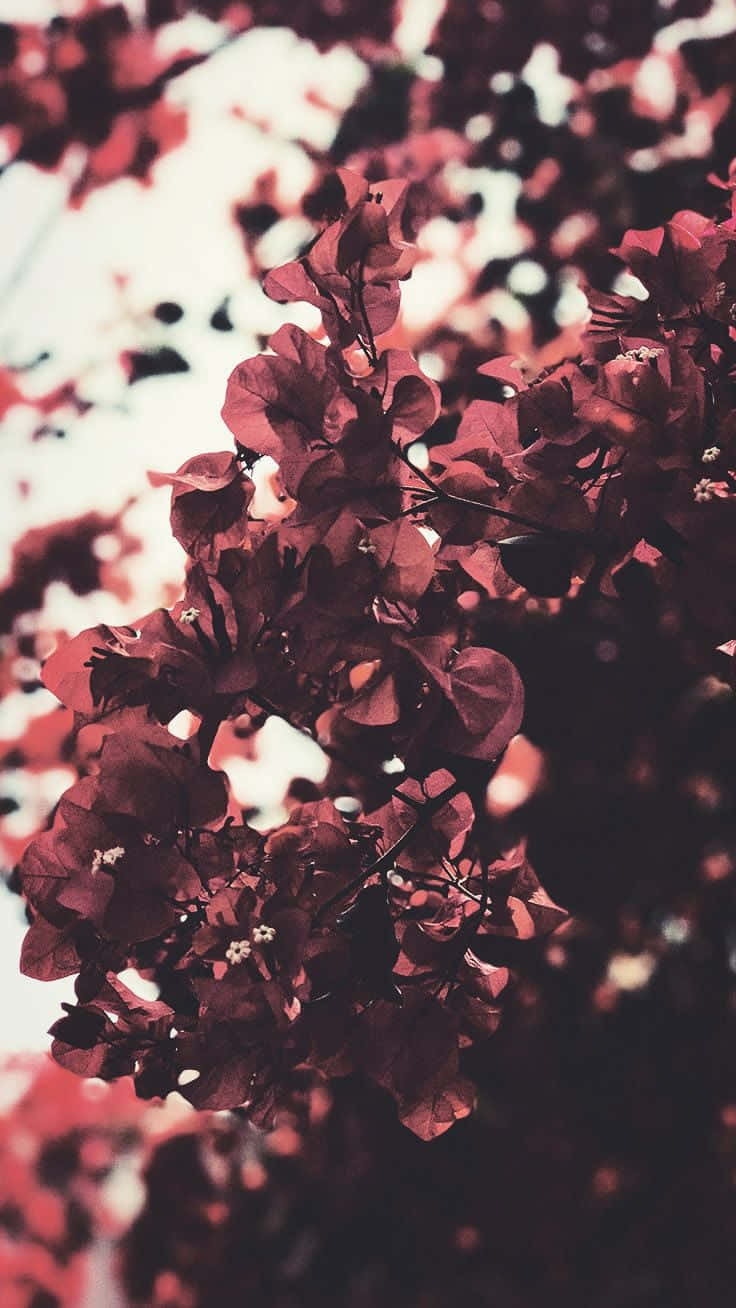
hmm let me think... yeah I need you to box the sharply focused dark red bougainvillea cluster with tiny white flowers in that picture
[21,170,736,1138]
